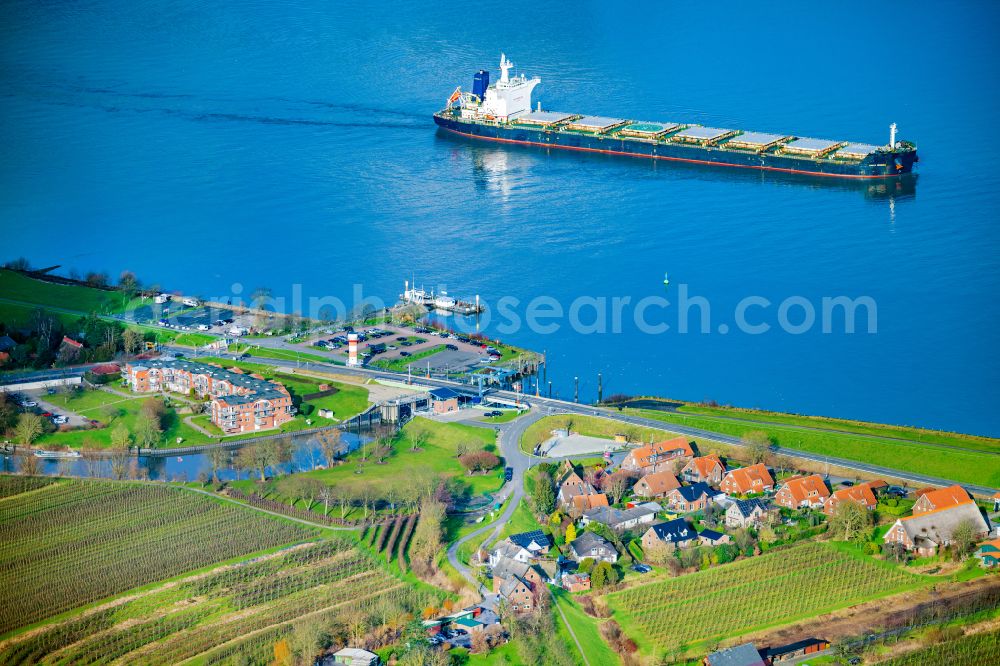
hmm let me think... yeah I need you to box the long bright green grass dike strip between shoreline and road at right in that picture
[628,410,1000,488]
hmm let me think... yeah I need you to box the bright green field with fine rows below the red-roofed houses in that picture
[607,542,928,653]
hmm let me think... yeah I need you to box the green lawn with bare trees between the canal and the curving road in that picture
[298,417,503,498]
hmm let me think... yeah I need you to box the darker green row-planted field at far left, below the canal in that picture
[0,481,316,632]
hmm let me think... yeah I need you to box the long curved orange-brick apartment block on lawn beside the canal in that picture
[122,359,295,434]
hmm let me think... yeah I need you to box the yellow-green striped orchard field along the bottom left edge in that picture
[0,537,443,665]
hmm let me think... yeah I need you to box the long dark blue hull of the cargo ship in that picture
[434,109,918,178]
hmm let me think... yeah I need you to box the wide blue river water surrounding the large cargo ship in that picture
[0,0,1000,435]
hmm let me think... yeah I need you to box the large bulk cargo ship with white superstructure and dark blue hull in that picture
[434,54,917,178]
